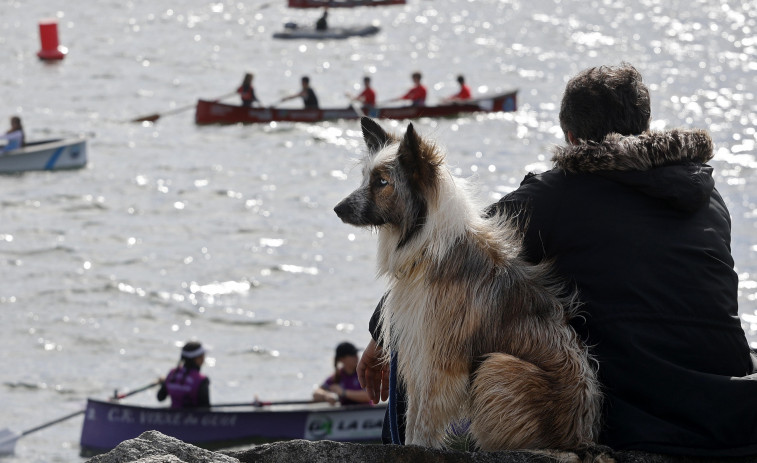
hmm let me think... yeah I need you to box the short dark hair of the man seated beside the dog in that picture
[560,63,651,142]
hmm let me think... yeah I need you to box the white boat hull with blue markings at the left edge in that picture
[0,138,87,173]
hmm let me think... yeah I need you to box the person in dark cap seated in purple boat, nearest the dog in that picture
[313,342,371,405]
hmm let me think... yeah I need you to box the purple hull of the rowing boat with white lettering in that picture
[80,399,386,455]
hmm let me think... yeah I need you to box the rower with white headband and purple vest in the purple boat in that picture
[158,341,210,408]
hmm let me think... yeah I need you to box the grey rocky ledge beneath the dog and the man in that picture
[87,431,755,463]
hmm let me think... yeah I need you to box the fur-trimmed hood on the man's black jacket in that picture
[552,130,715,211]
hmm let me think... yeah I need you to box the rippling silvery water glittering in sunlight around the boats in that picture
[0,0,757,463]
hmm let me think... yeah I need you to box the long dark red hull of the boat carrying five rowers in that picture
[195,90,517,125]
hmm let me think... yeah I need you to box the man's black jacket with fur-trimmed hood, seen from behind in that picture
[490,130,757,455]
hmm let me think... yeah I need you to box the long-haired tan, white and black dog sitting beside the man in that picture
[334,117,601,451]
